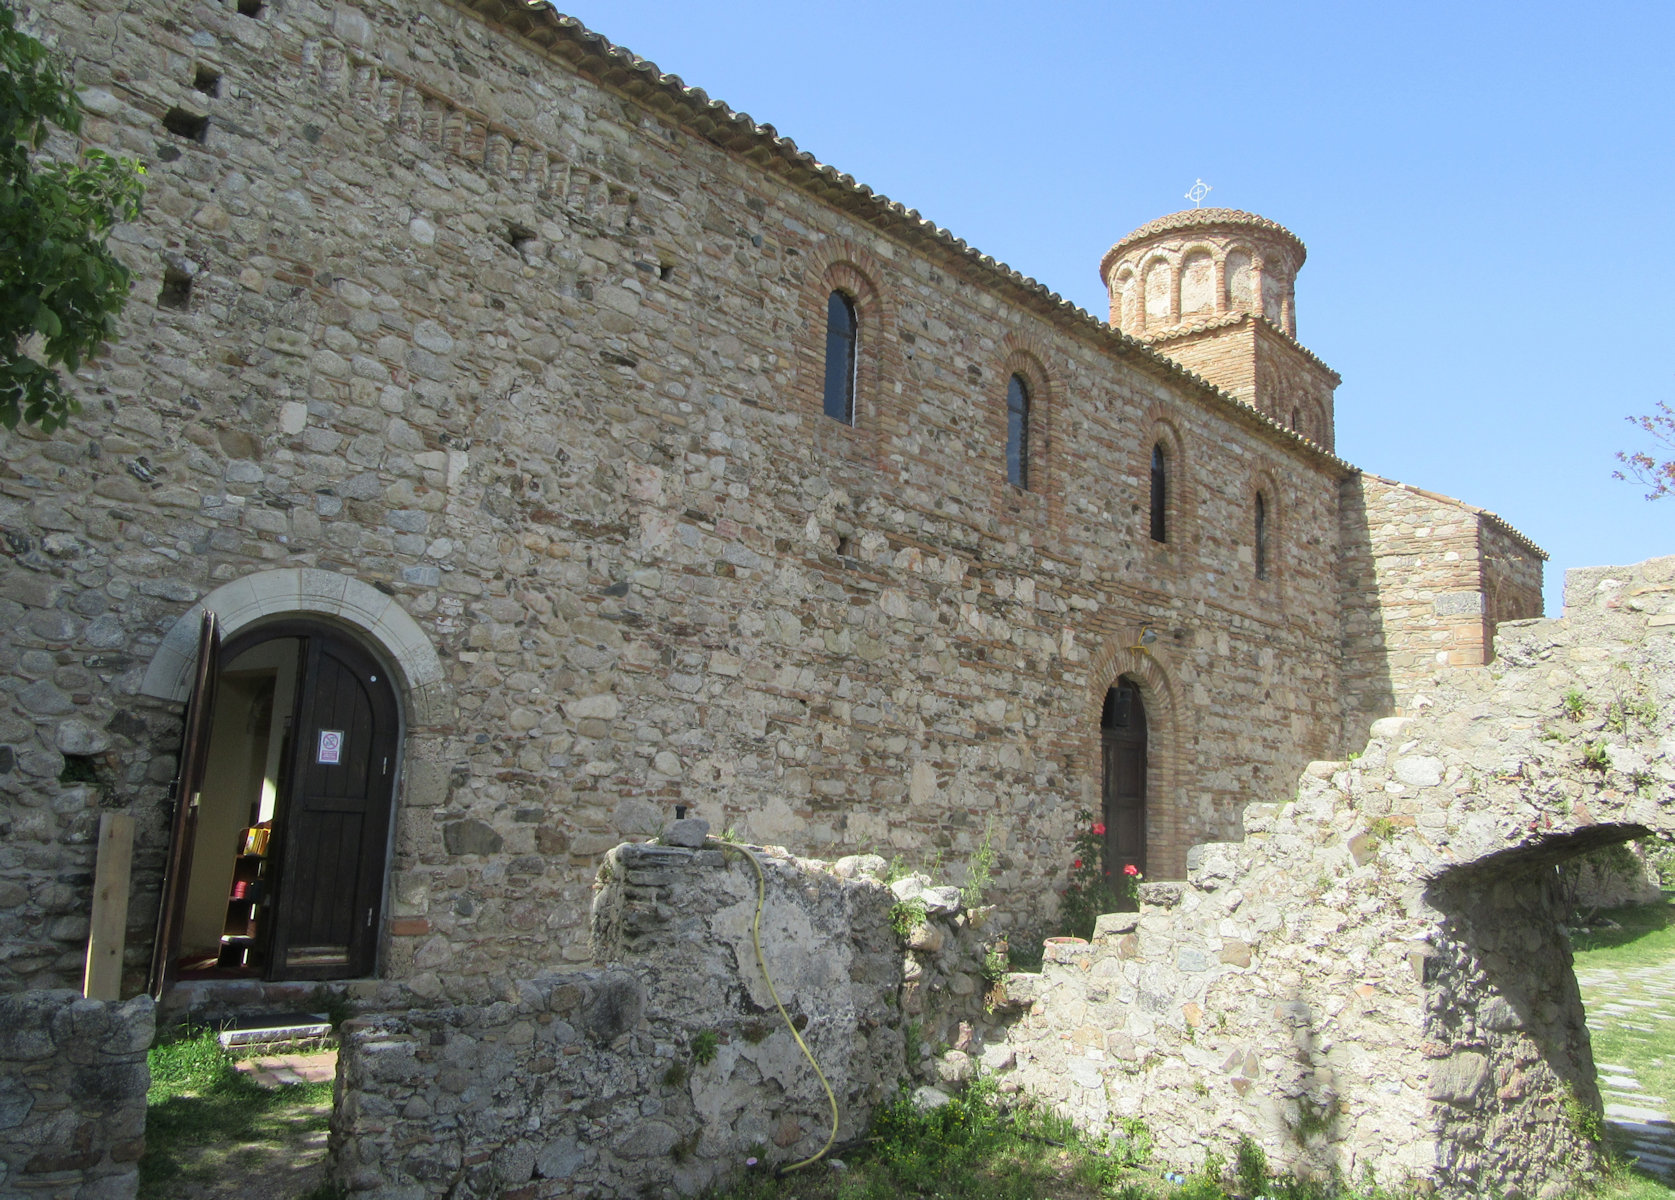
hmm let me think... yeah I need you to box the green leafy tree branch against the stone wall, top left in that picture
[0,0,144,431]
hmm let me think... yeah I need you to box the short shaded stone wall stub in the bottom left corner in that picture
[0,991,154,1200]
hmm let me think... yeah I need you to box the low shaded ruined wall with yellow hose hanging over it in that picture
[330,840,992,1200]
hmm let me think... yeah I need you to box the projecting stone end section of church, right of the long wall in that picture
[1340,473,1546,727]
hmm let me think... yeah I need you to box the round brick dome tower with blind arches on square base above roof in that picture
[1099,208,1342,449]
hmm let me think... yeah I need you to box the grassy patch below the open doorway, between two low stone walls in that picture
[139,1031,332,1200]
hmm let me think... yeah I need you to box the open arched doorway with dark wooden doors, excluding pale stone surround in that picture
[159,620,400,980]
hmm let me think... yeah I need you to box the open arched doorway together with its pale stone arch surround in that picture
[141,568,451,996]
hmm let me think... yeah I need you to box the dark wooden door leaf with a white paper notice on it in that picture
[268,634,399,979]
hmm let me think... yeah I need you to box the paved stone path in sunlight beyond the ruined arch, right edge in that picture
[1576,962,1675,1187]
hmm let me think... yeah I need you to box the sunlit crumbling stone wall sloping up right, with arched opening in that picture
[984,558,1675,1197]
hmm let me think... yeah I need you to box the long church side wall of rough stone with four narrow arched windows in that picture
[0,0,1343,989]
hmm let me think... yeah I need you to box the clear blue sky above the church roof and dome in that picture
[579,0,1675,613]
